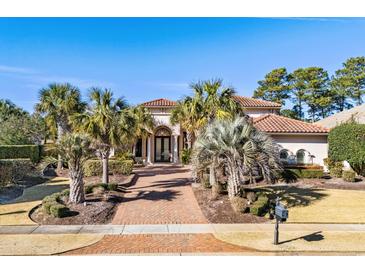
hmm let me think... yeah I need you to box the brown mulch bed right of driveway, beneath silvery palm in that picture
[193,185,269,223]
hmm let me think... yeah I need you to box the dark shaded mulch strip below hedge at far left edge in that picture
[0,176,48,204]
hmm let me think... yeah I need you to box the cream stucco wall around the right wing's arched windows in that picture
[272,135,328,166]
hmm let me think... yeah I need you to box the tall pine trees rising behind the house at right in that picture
[253,56,365,122]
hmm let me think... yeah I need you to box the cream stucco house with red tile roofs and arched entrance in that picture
[134,95,328,165]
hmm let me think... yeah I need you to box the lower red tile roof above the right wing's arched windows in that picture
[253,114,329,133]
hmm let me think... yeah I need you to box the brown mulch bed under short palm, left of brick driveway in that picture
[30,191,123,225]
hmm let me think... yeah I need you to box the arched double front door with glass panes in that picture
[155,127,171,162]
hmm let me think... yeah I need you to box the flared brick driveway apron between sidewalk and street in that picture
[64,234,256,255]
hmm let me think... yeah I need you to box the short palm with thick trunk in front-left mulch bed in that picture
[57,133,94,204]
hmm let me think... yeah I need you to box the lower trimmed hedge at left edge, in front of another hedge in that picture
[0,159,33,185]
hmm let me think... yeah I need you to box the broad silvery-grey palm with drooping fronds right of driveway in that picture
[193,117,281,198]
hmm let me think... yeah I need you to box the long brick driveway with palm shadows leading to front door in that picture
[112,165,207,224]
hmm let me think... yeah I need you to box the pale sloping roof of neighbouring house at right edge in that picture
[315,104,365,129]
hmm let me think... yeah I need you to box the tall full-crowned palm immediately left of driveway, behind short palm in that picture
[72,88,134,184]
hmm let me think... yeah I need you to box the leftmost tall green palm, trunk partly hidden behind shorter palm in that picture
[35,83,85,169]
